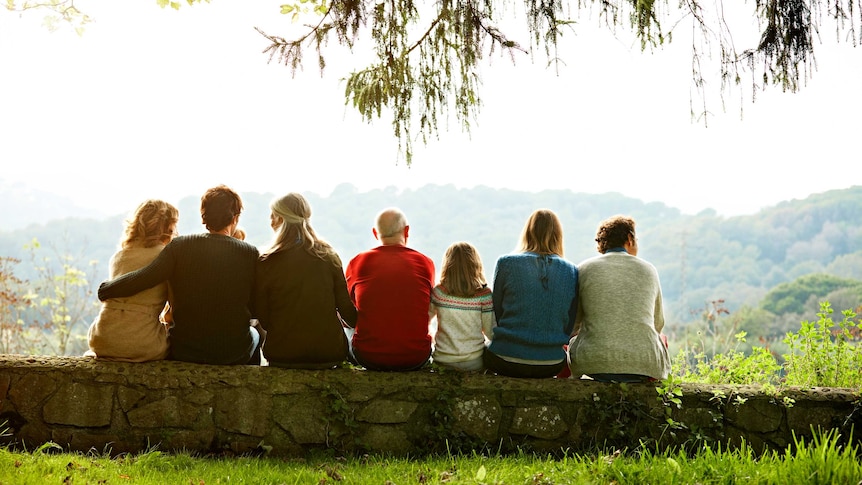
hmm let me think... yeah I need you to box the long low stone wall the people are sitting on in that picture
[0,355,862,456]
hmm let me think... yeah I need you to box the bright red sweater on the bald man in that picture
[345,245,434,367]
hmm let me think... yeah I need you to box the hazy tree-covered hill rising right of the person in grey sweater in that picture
[642,186,862,316]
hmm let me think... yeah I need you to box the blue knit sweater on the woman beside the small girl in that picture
[488,252,578,362]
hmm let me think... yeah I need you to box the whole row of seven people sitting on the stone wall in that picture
[93,185,670,382]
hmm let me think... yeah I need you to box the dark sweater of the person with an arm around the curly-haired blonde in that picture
[99,234,258,364]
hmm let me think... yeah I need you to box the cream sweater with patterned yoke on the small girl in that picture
[428,285,495,363]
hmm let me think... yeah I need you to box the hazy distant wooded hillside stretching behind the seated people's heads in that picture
[0,184,862,328]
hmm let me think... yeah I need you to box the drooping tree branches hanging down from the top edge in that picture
[246,0,862,164]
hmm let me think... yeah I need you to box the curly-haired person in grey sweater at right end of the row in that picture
[568,216,670,382]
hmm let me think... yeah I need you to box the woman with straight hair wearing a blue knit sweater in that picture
[483,209,578,378]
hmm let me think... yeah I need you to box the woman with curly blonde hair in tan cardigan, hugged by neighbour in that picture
[87,200,179,362]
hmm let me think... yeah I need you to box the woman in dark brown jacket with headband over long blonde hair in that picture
[254,193,356,369]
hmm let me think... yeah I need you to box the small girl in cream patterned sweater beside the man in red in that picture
[428,242,496,371]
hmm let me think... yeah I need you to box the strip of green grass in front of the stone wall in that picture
[0,432,862,485]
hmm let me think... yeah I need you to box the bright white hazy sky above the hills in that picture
[0,0,862,216]
